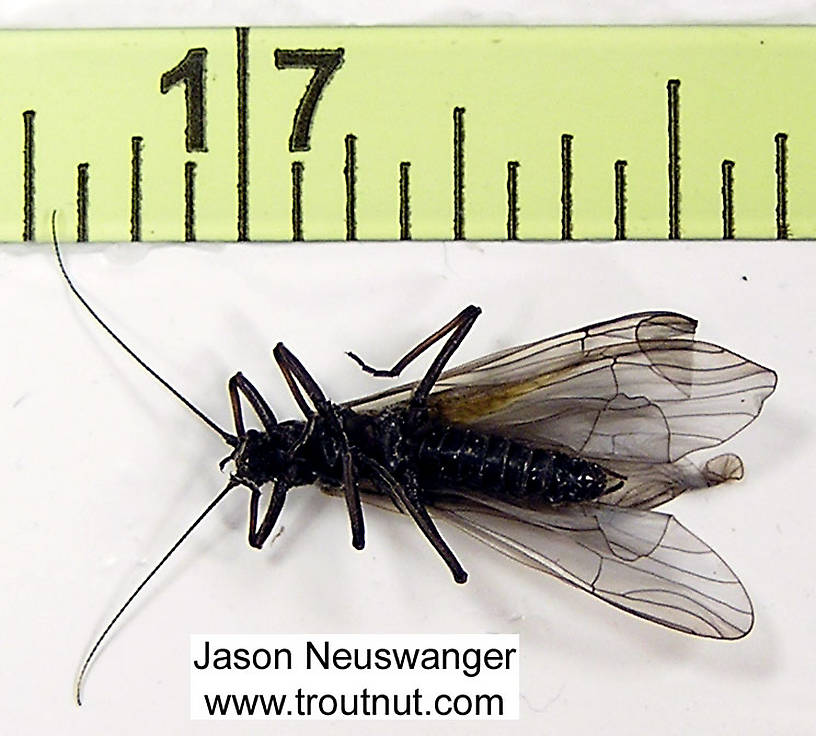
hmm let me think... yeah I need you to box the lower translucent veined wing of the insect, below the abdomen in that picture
[434,499,754,639]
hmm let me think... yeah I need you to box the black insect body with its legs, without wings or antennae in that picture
[222,306,622,583]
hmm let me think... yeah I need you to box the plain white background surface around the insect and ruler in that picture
[0,0,816,736]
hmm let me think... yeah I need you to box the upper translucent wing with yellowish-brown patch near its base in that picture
[349,312,776,465]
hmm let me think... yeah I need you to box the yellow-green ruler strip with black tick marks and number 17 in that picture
[0,27,816,242]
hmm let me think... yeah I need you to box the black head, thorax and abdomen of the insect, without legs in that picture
[236,400,622,536]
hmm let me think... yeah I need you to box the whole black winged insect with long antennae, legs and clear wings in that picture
[55,227,776,700]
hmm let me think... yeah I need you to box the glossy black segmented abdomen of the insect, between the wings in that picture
[417,426,607,503]
